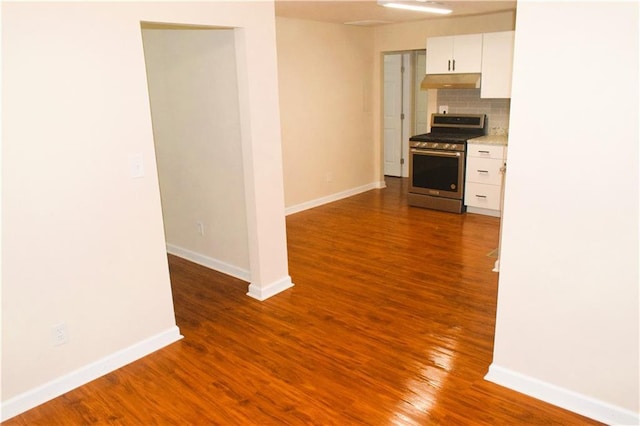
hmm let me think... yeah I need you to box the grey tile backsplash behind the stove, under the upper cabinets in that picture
[438,89,511,135]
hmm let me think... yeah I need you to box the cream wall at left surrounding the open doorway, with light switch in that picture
[2,2,291,418]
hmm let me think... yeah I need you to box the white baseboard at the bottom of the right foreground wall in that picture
[485,364,640,425]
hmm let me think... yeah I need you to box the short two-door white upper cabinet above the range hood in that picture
[427,34,482,74]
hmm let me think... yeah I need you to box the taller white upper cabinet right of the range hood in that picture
[480,31,515,98]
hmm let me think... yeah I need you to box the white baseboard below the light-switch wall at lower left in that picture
[1,326,182,422]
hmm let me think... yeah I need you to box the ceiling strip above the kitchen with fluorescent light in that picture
[275,0,516,26]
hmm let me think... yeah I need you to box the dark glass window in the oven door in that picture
[412,153,460,192]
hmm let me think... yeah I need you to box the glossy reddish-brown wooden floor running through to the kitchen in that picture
[4,178,598,425]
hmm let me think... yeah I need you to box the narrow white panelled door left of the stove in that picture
[383,54,402,176]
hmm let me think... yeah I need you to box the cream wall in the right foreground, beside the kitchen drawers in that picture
[488,2,640,424]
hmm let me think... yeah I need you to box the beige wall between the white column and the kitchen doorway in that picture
[276,18,378,208]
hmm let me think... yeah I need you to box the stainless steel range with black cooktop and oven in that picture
[408,114,487,213]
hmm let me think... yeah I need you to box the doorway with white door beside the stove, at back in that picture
[382,49,428,177]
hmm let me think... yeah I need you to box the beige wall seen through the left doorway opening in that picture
[142,28,249,279]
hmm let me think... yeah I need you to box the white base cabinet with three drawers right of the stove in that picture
[464,142,507,217]
